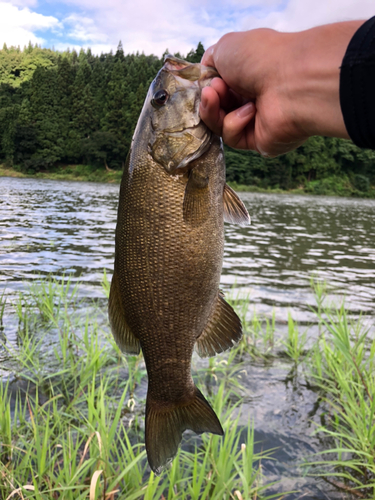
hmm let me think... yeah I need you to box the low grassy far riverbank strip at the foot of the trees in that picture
[0,164,375,198]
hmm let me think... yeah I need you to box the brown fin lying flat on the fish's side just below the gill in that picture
[183,169,210,225]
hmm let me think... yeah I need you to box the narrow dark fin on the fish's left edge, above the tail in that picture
[108,271,141,354]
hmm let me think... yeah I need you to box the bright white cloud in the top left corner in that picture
[0,2,59,47]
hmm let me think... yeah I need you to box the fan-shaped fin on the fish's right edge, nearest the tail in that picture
[195,292,242,358]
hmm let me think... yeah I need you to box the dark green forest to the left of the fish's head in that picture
[0,43,162,170]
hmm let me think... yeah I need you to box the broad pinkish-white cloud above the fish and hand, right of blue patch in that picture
[52,0,375,55]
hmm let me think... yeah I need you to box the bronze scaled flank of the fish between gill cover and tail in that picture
[115,152,224,386]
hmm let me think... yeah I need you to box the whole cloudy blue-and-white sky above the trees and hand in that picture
[0,0,375,56]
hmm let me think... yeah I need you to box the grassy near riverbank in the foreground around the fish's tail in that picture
[0,275,375,500]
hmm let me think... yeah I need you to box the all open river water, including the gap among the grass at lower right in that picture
[0,178,375,499]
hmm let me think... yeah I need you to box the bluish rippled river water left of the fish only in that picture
[0,178,118,295]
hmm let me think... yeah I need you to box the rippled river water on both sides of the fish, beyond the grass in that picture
[0,178,375,320]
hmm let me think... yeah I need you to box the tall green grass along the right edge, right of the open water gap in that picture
[231,276,375,500]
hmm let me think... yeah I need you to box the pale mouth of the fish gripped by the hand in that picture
[163,54,220,87]
